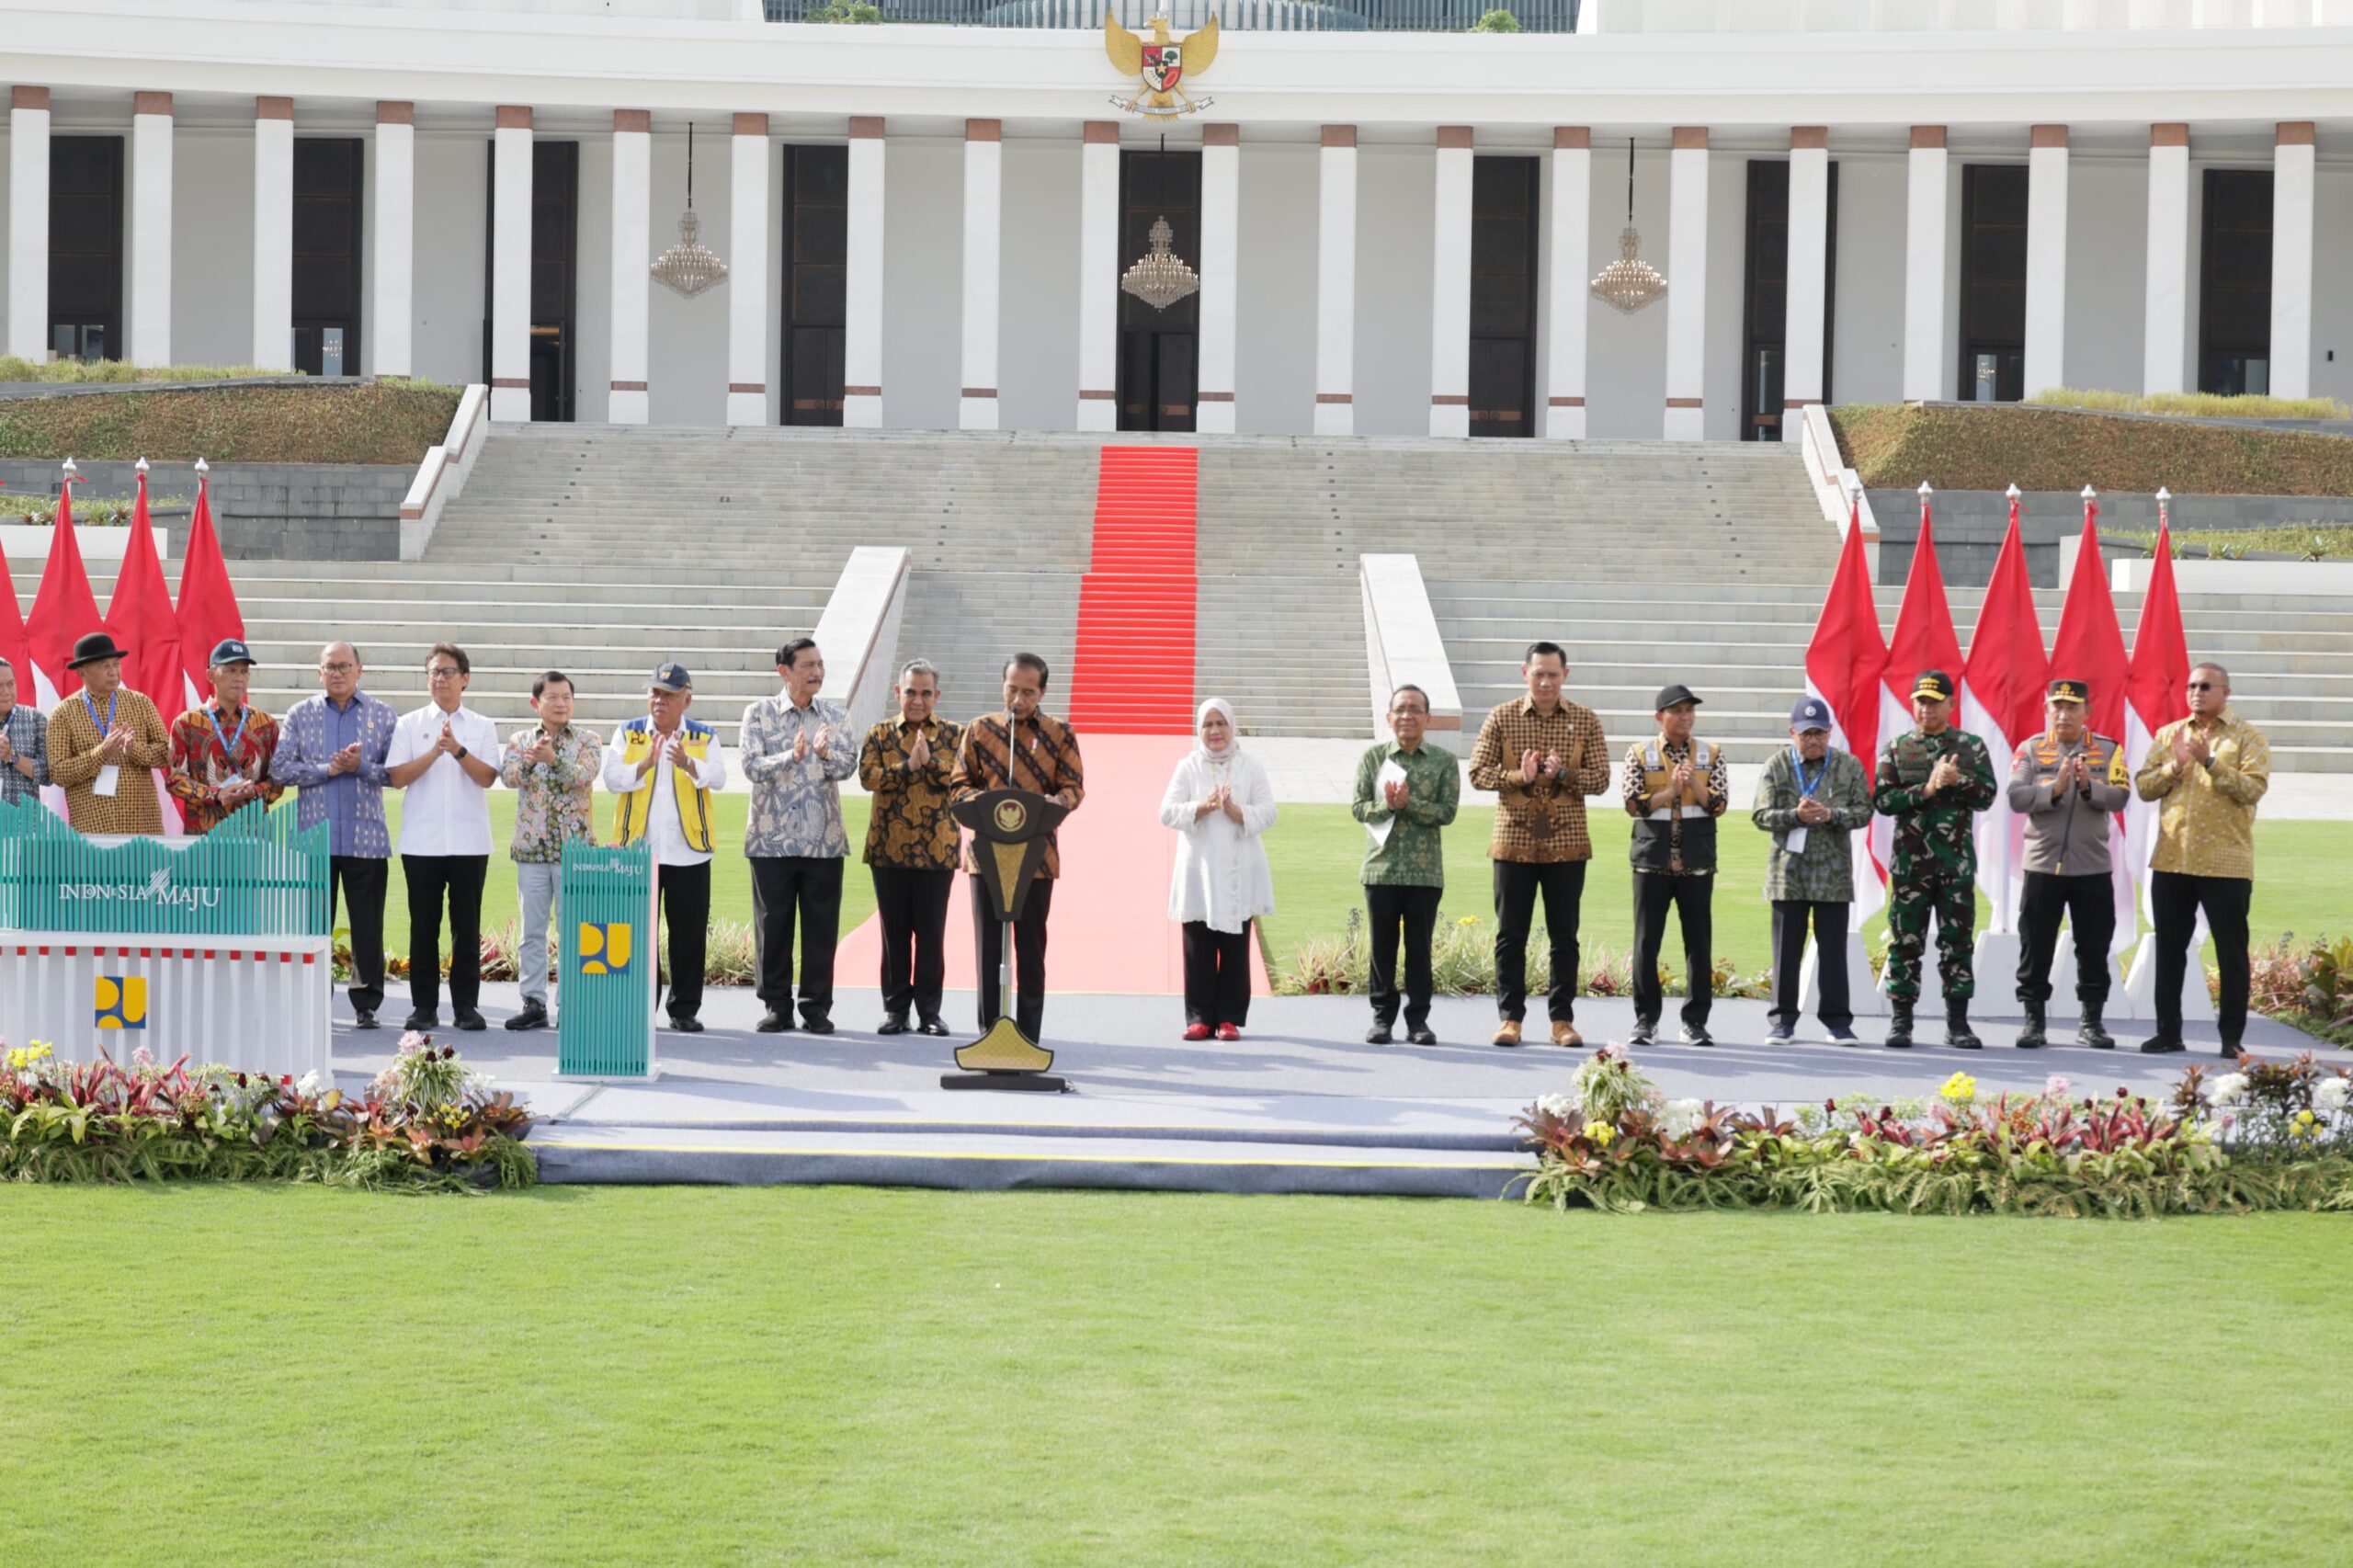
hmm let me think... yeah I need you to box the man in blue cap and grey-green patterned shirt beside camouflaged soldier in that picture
[1748,697,1870,1045]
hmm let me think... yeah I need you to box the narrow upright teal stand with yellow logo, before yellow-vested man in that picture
[555,838,661,1078]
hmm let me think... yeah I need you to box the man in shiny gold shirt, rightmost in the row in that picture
[2131,664,2270,1057]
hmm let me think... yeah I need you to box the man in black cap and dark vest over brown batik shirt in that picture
[1623,685,1732,1045]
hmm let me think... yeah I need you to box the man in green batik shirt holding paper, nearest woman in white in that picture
[1356,685,1461,1045]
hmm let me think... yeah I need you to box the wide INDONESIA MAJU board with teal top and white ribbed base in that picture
[0,801,335,1076]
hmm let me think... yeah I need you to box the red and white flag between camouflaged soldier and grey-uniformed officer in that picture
[1960,485,2050,932]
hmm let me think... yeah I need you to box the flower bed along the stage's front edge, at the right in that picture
[1518,1050,2353,1220]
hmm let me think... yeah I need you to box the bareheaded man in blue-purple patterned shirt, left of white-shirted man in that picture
[270,642,400,1028]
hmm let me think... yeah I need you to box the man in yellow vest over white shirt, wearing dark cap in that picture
[605,664,727,1034]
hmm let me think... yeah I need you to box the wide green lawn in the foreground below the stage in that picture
[0,1187,2353,1568]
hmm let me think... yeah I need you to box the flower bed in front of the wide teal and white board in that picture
[0,1034,539,1191]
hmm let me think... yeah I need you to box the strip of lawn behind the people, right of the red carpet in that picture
[1261,805,2353,974]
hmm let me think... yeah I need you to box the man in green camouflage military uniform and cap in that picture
[1870,668,1995,1050]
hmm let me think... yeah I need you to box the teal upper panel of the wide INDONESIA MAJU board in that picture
[0,801,327,937]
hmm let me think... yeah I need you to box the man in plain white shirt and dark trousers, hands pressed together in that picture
[383,642,499,1028]
